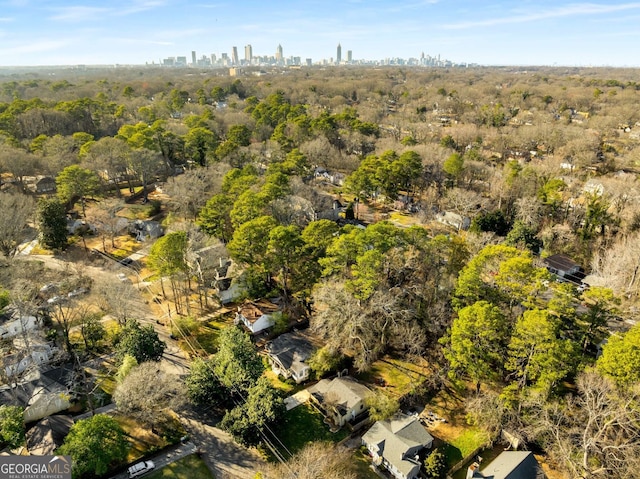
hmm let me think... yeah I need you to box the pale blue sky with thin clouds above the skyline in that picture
[0,0,640,66]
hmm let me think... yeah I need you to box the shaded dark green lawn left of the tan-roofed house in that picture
[277,404,349,454]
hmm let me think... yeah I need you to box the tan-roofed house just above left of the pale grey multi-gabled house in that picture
[307,376,372,427]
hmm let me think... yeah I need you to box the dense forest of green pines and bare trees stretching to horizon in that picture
[0,67,640,478]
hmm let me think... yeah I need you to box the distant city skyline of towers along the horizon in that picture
[151,43,464,70]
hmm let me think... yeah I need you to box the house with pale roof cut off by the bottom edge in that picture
[467,451,546,479]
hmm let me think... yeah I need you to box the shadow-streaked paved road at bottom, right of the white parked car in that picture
[181,413,265,479]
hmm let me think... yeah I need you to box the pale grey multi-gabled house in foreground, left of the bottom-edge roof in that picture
[362,413,433,479]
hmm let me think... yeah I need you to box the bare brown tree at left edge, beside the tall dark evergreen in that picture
[0,193,35,258]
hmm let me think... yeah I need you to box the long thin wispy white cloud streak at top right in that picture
[442,2,640,30]
